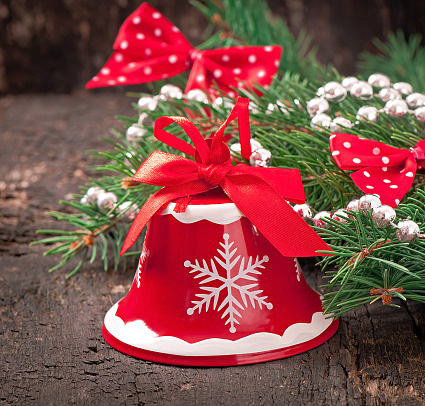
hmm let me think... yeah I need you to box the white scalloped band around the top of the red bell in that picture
[160,203,245,224]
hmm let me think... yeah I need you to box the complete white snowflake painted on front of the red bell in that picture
[184,234,273,333]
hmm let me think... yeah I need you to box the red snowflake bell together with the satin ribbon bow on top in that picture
[103,99,338,366]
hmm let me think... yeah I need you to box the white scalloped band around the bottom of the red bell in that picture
[104,303,334,356]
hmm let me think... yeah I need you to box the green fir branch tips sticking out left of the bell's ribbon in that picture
[32,127,157,277]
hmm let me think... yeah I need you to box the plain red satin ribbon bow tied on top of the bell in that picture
[121,98,330,257]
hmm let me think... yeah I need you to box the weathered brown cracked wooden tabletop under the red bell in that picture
[0,94,425,406]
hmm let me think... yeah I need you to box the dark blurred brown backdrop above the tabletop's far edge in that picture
[0,0,425,94]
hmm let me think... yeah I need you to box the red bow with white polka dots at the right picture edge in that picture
[329,134,425,207]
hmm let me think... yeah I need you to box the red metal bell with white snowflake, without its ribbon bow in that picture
[103,193,337,366]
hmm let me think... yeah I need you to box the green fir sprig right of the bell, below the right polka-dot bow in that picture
[316,190,425,317]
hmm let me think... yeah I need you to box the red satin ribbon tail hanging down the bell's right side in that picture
[222,179,332,257]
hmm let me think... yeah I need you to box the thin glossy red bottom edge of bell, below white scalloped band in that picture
[102,312,339,367]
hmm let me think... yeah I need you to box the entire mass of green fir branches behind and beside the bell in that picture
[36,0,425,316]
